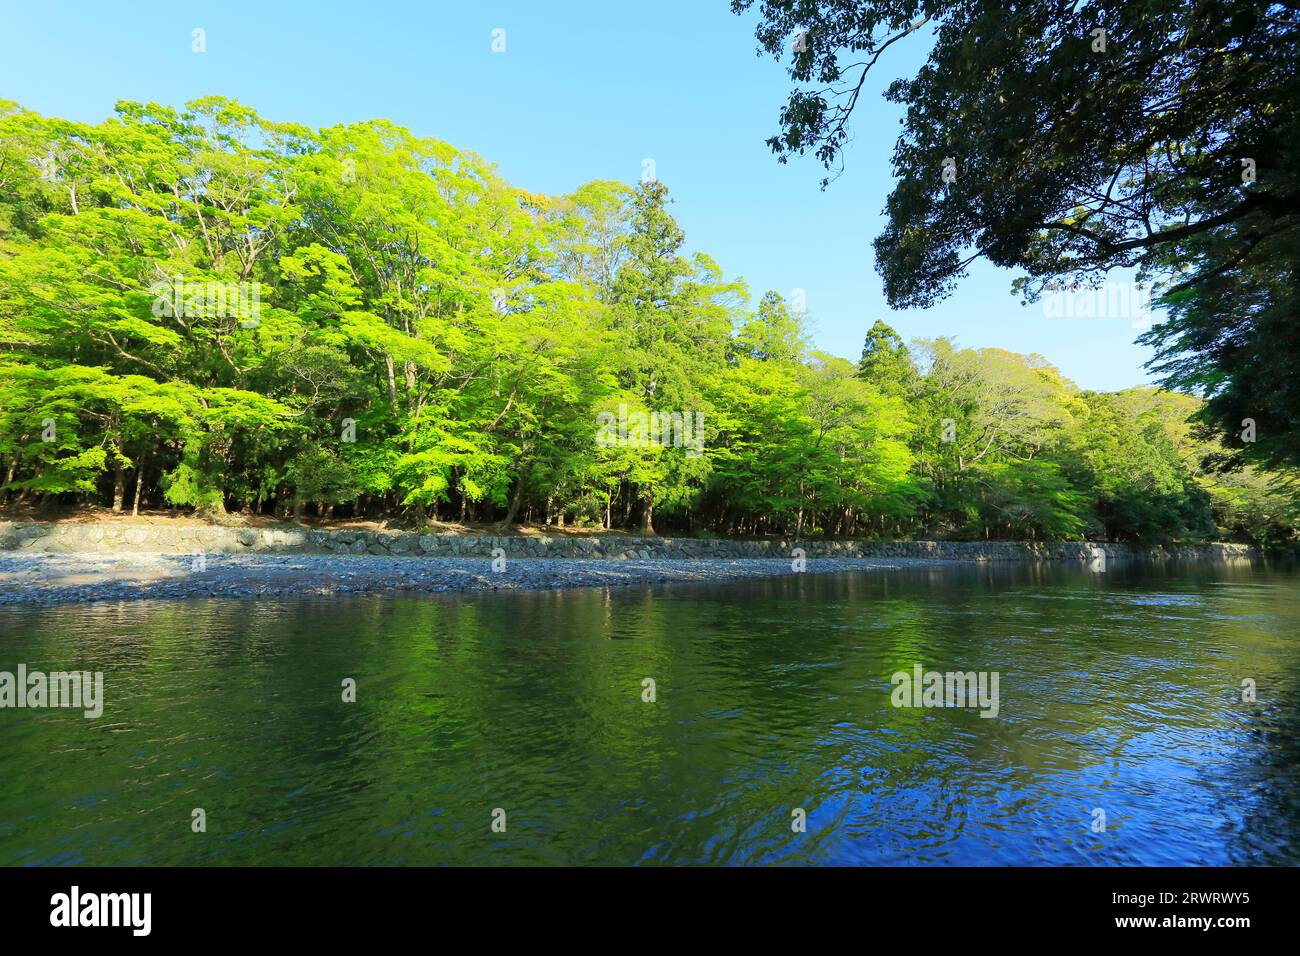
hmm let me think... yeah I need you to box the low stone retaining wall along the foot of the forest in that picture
[0,522,1255,561]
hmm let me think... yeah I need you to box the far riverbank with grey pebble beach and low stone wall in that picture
[0,522,1255,606]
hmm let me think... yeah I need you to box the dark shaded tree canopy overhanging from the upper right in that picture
[732,0,1300,466]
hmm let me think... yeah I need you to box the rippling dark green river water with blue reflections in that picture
[0,566,1300,865]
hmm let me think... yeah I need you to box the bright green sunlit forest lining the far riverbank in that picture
[0,96,1300,545]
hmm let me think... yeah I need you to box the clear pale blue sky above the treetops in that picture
[0,0,1149,389]
